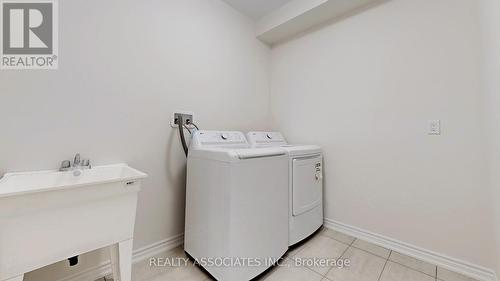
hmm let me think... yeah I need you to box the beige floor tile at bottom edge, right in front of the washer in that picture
[264,260,323,281]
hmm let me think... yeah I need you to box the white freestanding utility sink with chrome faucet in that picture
[0,164,147,281]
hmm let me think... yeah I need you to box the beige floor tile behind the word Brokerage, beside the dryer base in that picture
[293,235,349,275]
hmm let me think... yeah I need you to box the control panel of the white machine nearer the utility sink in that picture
[192,130,249,148]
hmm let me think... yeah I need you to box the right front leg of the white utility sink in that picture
[109,239,133,281]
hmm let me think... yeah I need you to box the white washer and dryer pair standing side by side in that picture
[184,130,323,281]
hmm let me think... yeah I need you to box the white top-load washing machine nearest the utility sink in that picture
[184,131,288,281]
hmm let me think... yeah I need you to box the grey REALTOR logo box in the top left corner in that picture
[0,0,58,69]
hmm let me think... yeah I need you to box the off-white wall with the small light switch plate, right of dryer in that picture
[271,0,498,268]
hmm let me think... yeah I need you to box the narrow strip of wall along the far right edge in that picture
[480,0,500,275]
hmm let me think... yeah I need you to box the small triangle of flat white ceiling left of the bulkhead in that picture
[224,0,291,20]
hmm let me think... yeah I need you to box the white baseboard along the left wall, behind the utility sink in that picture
[58,233,184,281]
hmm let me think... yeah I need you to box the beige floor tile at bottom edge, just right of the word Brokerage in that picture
[326,247,386,281]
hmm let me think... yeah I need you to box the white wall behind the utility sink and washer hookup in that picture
[0,0,270,281]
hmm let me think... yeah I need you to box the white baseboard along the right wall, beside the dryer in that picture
[324,218,499,281]
